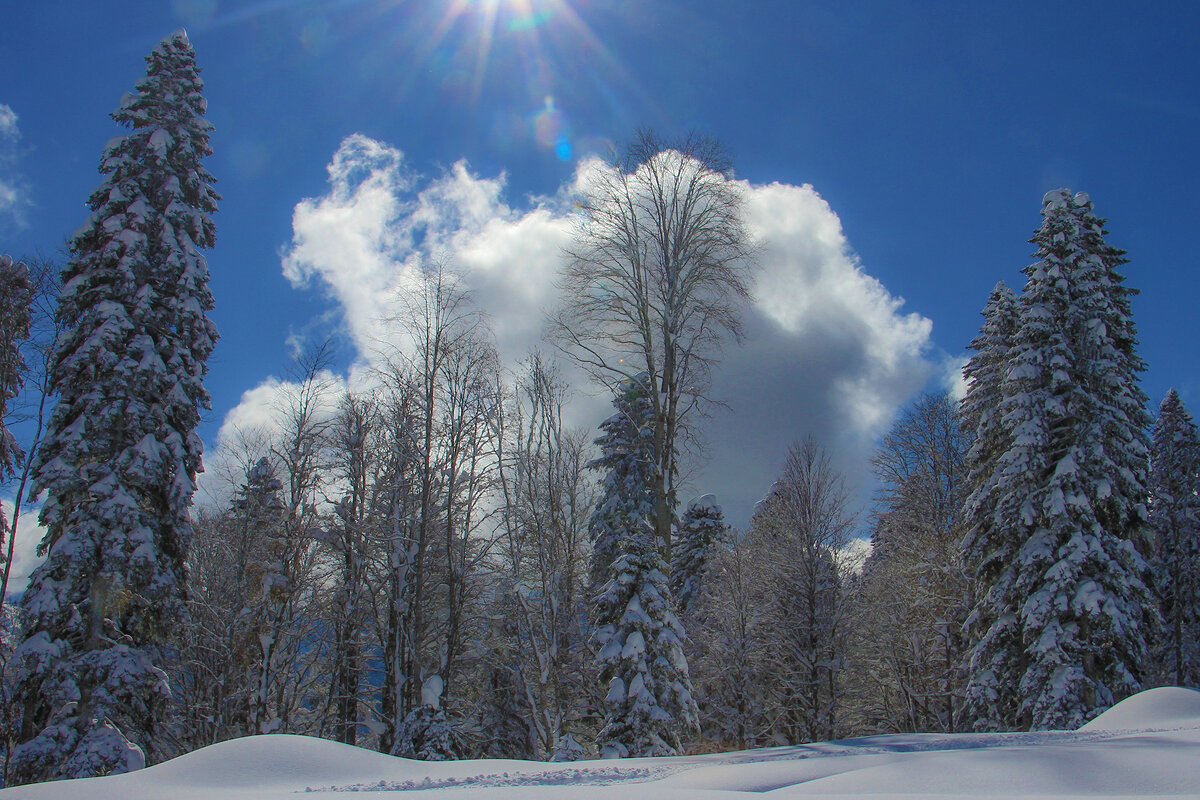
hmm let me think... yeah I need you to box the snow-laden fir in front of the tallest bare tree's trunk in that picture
[592,375,697,758]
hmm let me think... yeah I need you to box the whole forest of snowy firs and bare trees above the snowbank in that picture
[0,26,1200,786]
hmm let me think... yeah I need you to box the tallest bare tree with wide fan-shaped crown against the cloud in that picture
[550,131,749,561]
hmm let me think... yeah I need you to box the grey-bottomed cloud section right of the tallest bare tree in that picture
[703,184,934,522]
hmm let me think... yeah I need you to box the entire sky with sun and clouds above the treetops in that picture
[0,0,1200,551]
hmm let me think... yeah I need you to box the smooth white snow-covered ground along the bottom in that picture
[0,688,1200,800]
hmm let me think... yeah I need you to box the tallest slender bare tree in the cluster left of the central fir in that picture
[385,265,500,754]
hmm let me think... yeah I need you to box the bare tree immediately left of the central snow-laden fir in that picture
[491,353,596,758]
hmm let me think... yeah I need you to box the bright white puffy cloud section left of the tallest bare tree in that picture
[283,134,571,371]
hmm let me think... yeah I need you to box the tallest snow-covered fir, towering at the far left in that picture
[12,30,220,782]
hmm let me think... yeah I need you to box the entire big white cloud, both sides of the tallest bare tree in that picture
[218,134,936,524]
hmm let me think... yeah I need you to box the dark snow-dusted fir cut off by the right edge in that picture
[1150,389,1200,686]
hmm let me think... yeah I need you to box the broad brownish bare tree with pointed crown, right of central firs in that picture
[692,438,854,748]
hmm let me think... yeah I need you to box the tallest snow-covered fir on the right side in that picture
[964,190,1158,729]
